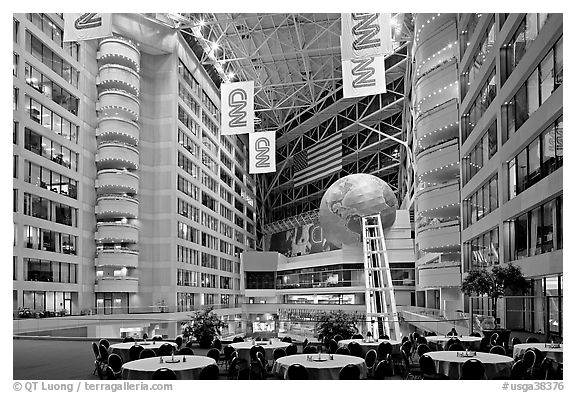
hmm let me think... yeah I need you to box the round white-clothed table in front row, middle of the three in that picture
[272,353,368,380]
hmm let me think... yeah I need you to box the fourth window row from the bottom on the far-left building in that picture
[24,192,78,227]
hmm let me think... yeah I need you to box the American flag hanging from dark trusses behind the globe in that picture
[292,132,342,187]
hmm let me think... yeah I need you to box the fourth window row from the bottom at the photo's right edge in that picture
[502,38,563,141]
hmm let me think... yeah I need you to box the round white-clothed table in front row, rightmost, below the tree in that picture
[426,351,514,379]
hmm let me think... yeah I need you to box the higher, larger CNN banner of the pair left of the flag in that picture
[220,81,254,135]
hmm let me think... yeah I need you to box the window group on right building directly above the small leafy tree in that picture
[464,227,500,272]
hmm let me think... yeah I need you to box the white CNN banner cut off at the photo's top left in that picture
[63,13,112,41]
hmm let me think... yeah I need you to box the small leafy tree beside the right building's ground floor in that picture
[461,263,530,319]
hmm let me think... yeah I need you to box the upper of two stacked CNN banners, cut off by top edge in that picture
[340,13,394,60]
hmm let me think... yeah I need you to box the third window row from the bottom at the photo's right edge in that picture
[508,116,564,199]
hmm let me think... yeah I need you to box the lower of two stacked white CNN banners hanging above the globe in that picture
[342,55,386,98]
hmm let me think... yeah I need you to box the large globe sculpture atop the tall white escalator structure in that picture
[319,173,398,247]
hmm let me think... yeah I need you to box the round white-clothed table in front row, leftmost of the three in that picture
[122,355,216,379]
